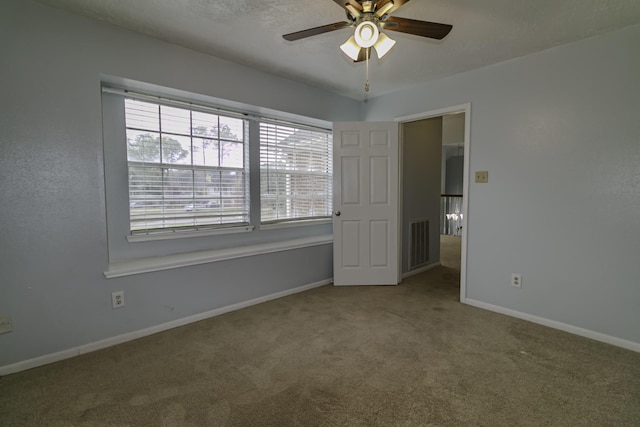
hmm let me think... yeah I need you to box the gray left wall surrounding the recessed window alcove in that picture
[0,0,361,367]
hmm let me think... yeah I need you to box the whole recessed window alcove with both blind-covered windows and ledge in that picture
[101,83,332,277]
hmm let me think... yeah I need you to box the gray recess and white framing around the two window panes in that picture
[101,83,333,260]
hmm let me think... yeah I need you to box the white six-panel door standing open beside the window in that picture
[333,122,399,286]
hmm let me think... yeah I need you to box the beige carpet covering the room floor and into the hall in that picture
[0,237,640,426]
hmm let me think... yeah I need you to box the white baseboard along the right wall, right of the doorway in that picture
[461,298,640,353]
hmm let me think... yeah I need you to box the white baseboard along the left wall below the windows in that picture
[0,279,332,376]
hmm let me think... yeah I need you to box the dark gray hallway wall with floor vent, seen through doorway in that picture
[402,117,442,273]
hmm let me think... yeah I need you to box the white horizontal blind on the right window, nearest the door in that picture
[260,122,333,223]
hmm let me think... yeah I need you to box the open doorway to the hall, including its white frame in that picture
[396,104,471,302]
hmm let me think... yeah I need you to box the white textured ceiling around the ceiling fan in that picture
[33,0,640,99]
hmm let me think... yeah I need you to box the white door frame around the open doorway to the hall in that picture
[395,102,471,303]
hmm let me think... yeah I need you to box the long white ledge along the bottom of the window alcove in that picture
[104,234,333,279]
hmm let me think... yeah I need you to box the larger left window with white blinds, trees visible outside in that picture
[124,97,249,234]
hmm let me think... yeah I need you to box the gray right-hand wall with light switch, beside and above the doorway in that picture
[366,25,640,348]
